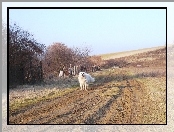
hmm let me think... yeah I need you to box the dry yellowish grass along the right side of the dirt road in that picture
[138,77,166,124]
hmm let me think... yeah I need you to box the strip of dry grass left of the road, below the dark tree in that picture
[9,80,77,111]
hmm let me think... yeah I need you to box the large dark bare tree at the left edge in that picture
[8,23,45,84]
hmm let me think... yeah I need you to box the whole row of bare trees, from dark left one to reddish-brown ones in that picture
[7,23,101,85]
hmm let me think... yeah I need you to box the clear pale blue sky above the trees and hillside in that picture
[2,2,174,55]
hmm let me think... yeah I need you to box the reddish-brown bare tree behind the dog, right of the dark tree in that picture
[43,43,94,78]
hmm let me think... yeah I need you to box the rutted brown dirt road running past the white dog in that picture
[10,69,165,124]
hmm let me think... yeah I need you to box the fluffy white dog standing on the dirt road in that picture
[78,72,95,90]
